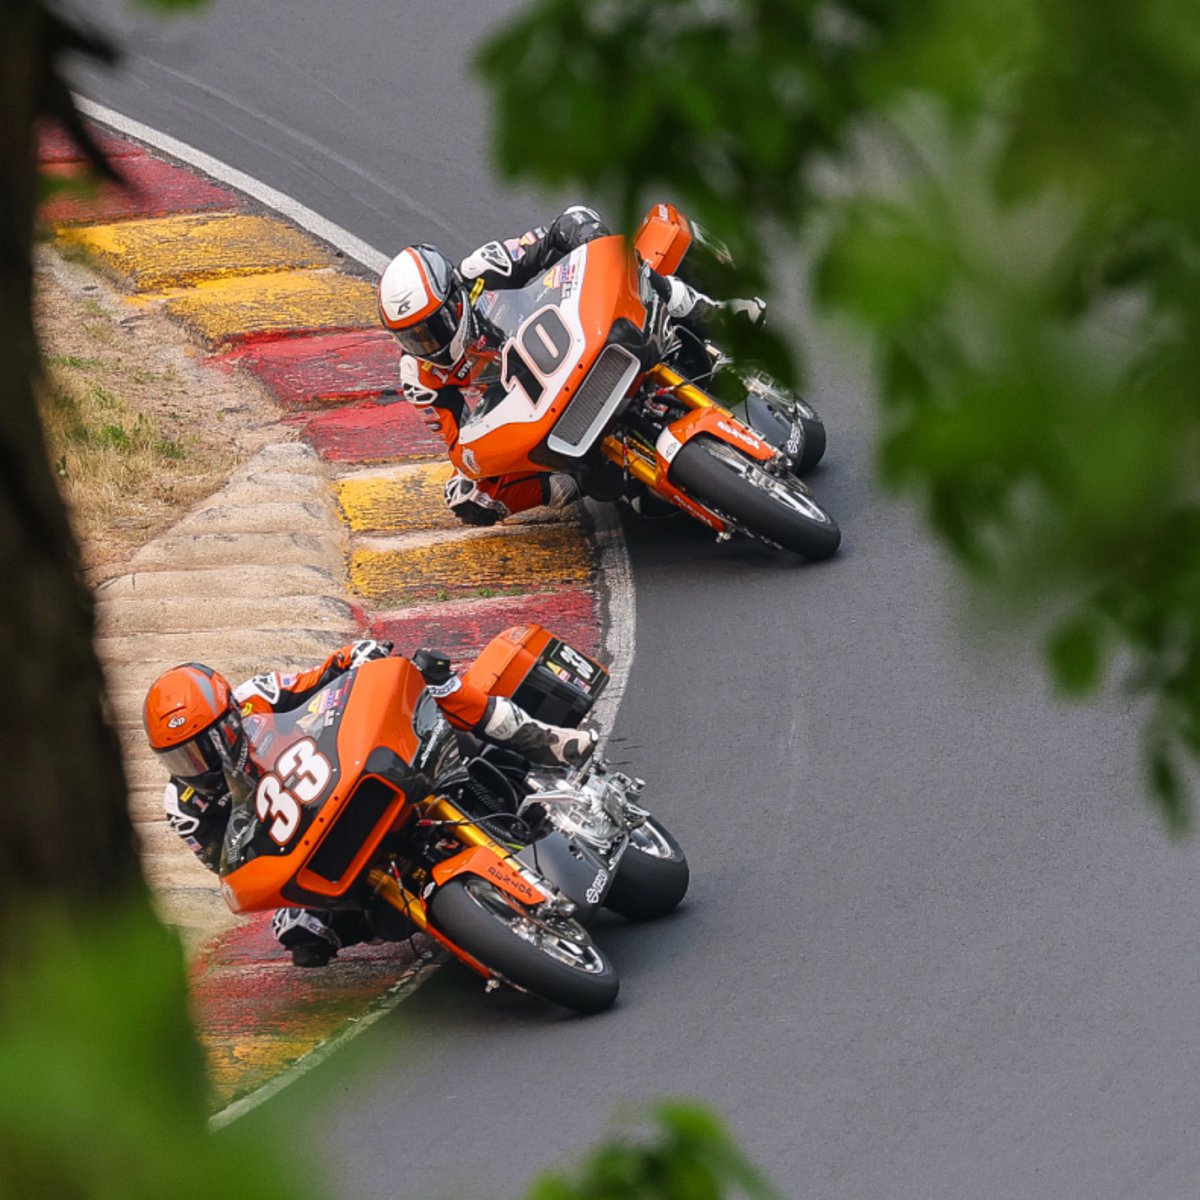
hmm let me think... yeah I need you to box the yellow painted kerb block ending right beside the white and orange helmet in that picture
[159,271,379,347]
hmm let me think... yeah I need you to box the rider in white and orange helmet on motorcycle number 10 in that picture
[379,205,763,526]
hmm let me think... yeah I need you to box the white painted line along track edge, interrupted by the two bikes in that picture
[68,103,637,1129]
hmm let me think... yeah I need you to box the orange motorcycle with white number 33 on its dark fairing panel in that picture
[221,625,688,1013]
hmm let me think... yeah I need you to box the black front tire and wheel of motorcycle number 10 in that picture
[670,436,841,560]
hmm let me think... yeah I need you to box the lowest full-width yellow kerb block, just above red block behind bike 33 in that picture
[350,523,592,605]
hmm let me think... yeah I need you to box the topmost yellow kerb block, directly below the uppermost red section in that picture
[58,214,336,292]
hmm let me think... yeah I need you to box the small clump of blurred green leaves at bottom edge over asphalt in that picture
[527,1102,775,1200]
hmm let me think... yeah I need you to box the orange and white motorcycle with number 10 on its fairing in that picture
[450,204,841,559]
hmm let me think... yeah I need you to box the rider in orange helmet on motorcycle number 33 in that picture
[144,640,595,967]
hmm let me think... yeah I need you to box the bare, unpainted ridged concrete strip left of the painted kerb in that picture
[96,444,364,953]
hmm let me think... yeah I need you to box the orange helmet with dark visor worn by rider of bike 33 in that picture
[142,662,246,792]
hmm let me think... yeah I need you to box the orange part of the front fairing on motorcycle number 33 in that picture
[221,658,425,912]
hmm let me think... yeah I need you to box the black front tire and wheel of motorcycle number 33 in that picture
[430,875,620,1013]
